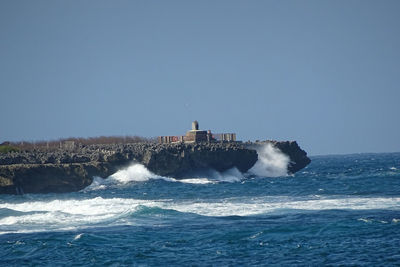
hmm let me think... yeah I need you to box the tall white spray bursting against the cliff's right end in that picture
[248,143,290,177]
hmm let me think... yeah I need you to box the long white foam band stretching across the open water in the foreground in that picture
[0,196,400,236]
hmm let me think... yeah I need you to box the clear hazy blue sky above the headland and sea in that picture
[0,0,400,155]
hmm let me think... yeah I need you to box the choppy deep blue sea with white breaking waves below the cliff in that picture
[0,148,400,266]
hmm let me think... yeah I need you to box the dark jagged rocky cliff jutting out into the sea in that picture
[0,141,311,194]
